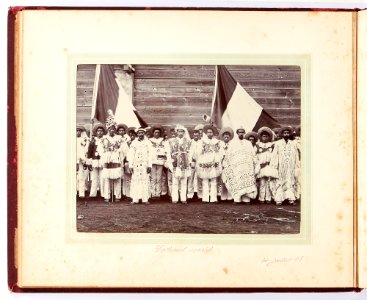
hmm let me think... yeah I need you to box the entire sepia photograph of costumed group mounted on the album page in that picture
[76,64,301,234]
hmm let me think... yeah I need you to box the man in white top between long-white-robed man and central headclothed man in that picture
[149,126,168,198]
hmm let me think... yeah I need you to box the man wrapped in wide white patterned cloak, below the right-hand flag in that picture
[222,127,257,204]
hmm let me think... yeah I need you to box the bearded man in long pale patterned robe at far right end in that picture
[270,126,300,205]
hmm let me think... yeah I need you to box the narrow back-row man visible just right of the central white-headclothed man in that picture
[187,126,203,200]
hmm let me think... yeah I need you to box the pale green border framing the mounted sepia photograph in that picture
[65,53,312,245]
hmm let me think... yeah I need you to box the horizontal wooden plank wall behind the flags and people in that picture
[77,65,301,128]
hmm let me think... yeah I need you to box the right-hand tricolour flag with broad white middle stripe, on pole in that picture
[211,66,280,132]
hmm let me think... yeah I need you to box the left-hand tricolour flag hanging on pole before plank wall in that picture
[91,65,147,127]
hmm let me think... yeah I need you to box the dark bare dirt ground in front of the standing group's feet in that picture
[77,198,301,234]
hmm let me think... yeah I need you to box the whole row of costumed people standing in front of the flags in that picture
[76,115,301,205]
